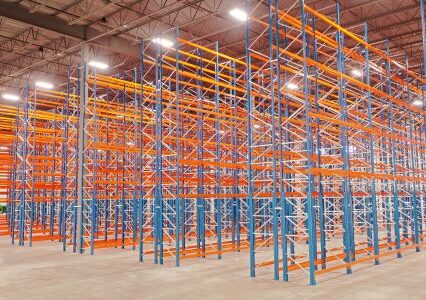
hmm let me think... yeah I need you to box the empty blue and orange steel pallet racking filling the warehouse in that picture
[0,0,426,285]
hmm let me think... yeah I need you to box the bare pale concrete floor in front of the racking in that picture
[0,238,426,300]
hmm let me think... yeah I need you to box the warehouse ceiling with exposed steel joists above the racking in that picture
[0,0,423,91]
